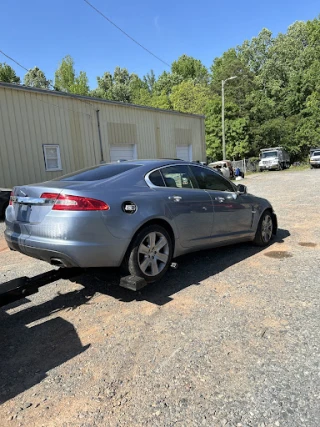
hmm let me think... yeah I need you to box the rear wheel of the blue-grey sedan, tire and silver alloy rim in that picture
[122,224,173,283]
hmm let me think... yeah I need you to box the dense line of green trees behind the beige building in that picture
[0,17,320,161]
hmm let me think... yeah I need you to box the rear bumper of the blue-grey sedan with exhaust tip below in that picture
[5,229,130,268]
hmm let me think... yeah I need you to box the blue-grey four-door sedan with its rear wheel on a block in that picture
[5,160,277,282]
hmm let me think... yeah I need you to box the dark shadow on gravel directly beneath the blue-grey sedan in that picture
[70,229,290,306]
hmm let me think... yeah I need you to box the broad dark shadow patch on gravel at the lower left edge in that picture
[0,308,89,409]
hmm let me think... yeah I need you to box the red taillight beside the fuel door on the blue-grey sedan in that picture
[41,193,110,211]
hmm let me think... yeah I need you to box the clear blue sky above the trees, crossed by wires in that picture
[0,0,320,88]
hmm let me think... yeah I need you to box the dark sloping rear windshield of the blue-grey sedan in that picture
[54,163,140,181]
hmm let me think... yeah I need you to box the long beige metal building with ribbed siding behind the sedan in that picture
[0,82,206,188]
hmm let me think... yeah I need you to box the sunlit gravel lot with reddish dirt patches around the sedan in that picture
[0,170,320,427]
